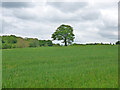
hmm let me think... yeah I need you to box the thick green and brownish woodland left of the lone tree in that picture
[0,35,54,49]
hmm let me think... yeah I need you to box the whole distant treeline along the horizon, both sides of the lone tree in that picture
[0,35,120,49]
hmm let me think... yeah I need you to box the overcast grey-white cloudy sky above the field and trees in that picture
[0,0,118,43]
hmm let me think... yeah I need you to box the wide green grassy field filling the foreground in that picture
[2,45,118,88]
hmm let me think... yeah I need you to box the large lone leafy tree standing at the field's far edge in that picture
[52,24,75,46]
